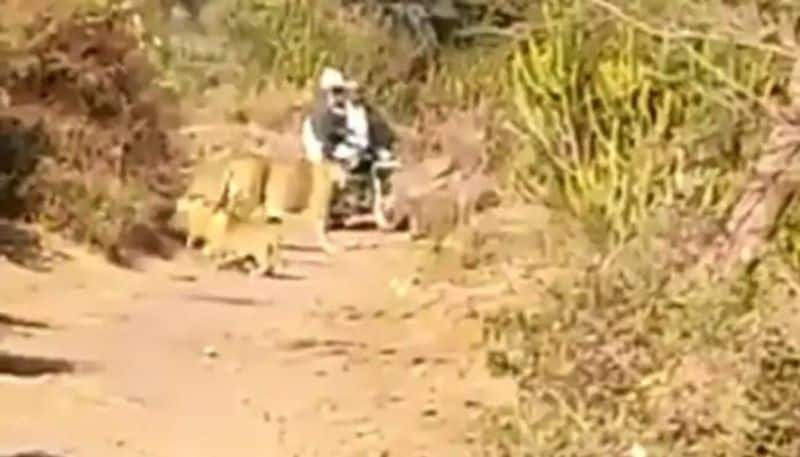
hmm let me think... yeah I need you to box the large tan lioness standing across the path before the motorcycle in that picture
[177,154,345,254]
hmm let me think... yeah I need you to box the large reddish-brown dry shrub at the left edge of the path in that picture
[0,5,181,256]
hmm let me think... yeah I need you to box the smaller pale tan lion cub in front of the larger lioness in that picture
[203,209,281,276]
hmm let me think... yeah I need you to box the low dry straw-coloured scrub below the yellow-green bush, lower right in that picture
[486,206,800,457]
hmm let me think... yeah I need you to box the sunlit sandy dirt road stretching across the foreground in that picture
[0,233,509,457]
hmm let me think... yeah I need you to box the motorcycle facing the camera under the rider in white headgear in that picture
[329,146,400,230]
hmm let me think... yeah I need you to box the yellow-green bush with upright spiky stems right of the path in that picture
[508,0,796,243]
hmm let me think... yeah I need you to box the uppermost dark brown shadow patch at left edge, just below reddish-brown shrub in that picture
[0,221,70,273]
